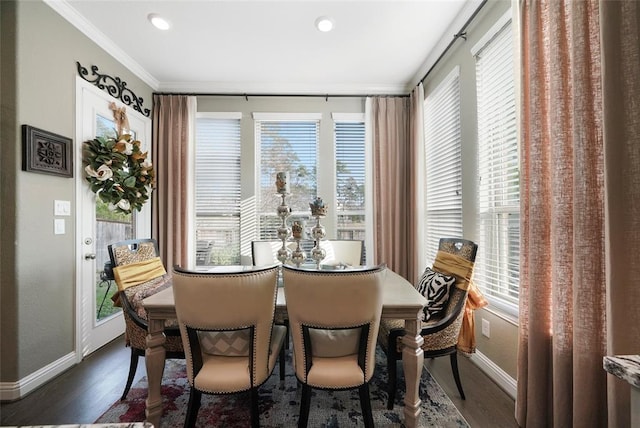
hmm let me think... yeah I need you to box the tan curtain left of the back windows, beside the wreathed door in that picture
[151,94,195,271]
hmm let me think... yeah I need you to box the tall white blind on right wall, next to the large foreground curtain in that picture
[475,21,520,314]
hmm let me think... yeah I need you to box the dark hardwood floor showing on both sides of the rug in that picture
[0,337,518,428]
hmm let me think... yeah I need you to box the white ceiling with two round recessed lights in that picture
[45,0,481,95]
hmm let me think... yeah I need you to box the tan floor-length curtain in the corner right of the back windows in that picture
[367,85,424,282]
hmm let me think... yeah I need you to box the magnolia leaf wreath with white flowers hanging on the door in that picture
[84,134,155,214]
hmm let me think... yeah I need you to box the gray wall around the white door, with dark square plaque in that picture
[0,0,152,382]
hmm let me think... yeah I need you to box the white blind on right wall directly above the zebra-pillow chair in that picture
[424,67,462,263]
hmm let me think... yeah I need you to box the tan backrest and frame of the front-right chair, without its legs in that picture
[283,266,386,388]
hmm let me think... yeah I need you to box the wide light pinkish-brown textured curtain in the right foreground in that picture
[516,0,640,427]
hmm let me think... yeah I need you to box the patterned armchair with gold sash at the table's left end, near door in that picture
[107,239,184,400]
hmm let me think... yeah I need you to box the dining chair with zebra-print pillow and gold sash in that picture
[378,238,478,410]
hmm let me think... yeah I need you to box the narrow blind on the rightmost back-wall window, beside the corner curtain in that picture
[334,121,365,240]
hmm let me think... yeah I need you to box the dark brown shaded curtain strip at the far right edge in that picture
[600,1,640,427]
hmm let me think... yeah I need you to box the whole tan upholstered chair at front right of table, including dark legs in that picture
[283,266,386,427]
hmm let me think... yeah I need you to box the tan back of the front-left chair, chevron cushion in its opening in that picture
[173,265,278,393]
